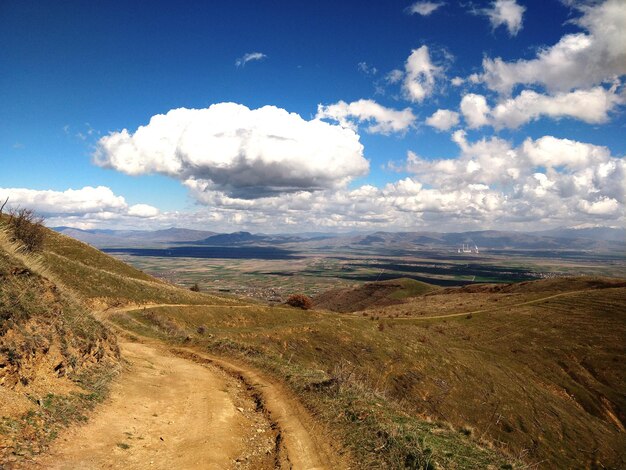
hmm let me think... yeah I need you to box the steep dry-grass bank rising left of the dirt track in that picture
[0,231,119,468]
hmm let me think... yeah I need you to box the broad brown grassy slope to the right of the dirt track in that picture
[117,279,626,468]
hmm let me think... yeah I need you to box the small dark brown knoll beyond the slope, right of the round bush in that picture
[314,278,439,313]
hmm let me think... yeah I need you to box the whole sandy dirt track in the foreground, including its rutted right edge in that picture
[35,307,338,470]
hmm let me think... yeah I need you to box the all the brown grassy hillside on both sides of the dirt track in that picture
[0,218,626,468]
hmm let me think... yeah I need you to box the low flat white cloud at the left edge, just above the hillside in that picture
[0,186,159,217]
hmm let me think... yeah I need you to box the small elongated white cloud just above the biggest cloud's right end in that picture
[315,100,415,134]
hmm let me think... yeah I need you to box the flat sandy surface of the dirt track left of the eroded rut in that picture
[38,338,276,470]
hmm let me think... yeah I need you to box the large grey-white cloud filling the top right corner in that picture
[479,0,626,94]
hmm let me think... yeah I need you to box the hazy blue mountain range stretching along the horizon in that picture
[54,227,626,254]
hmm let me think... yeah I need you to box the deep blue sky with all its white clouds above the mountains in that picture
[0,0,626,233]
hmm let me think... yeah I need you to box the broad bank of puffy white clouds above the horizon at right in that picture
[394,131,626,229]
